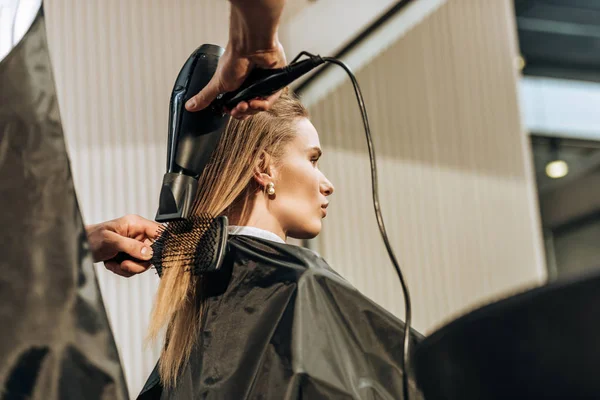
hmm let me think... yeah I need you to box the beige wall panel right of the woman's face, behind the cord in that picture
[306,0,546,333]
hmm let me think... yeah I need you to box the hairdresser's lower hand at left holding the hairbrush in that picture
[85,215,160,278]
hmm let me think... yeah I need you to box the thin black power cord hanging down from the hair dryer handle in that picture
[292,51,412,400]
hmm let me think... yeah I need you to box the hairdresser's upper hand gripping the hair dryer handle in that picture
[185,43,286,119]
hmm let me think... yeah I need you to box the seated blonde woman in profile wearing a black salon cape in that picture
[139,93,421,399]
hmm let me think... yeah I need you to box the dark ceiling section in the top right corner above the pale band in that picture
[514,0,600,81]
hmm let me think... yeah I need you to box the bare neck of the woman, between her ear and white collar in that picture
[228,191,287,241]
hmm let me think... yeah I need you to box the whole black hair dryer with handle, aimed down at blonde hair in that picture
[155,44,324,222]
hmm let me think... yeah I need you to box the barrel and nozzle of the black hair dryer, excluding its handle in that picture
[155,44,229,222]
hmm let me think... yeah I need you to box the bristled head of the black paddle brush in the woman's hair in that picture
[152,213,221,275]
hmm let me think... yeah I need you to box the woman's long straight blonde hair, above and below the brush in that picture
[149,91,308,387]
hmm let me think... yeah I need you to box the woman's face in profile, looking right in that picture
[269,118,333,239]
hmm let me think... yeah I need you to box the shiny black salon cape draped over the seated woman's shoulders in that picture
[138,236,422,400]
